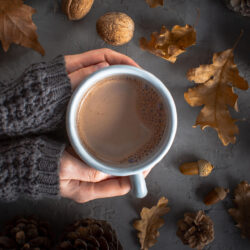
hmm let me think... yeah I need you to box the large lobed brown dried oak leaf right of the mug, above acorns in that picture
[184,49,248,146]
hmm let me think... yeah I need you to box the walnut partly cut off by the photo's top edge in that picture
[62,0,94,20]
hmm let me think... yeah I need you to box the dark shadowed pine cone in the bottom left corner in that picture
[0,217,51,250]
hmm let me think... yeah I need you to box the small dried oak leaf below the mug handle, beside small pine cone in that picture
[134,197,170,250]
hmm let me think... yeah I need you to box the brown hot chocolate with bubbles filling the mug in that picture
[77,75,167,164]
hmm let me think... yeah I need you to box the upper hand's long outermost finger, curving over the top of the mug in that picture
[65,48,140,74]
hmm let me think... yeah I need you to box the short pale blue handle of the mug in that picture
[130,172,148,198]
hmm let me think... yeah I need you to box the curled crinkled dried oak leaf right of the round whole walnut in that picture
[140,24,196,63]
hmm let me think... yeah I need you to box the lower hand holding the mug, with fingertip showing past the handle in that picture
[59,149,150,203]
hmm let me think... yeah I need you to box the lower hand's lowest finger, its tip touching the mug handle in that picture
[61,177,131,203]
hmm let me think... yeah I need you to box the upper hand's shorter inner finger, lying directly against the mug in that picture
[69,62,109,89]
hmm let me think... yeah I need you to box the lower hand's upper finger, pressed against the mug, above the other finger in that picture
[59,151,110,182]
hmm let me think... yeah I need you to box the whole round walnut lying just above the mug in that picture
[96,12,135,46]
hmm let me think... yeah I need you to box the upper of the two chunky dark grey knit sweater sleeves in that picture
[0,56,72,137]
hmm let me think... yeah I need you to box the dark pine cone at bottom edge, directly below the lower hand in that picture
[58,219,122,250]
